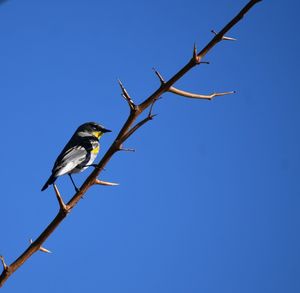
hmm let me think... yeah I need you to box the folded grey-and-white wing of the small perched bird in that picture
[52,145,88,177]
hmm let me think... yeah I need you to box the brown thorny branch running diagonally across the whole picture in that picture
[0,0,262,287]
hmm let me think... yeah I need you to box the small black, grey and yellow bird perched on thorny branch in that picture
[42,122,111,191]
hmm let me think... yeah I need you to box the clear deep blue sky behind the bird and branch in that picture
[0,0,300,293]
